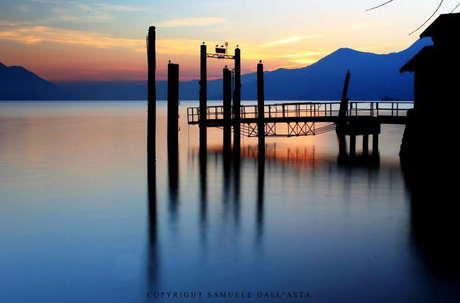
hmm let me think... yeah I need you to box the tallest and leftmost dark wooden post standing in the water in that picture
[147,26,157,161]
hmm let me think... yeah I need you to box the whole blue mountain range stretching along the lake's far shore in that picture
[0,39,432,100]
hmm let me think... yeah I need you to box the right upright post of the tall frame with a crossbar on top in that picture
[233,47,241,154]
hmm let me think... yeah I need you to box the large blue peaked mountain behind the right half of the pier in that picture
[242,40,431,100]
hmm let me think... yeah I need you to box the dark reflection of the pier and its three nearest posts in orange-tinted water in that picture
[188,144,388,258]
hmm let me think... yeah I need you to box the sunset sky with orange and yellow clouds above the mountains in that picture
[0,0,460,82]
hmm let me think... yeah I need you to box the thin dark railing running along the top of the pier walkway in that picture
[187,101,413,124]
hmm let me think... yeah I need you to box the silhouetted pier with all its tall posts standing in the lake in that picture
[147,27,413,159]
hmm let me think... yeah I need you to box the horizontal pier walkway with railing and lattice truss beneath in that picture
[187,101,413,137]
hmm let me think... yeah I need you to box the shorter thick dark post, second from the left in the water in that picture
[168,63,179,154]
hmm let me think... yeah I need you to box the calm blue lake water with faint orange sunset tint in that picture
[0,102,460,303]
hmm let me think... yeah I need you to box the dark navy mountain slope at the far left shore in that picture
[0,63,81,100]
